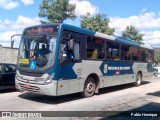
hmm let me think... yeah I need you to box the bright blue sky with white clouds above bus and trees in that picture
[0,0,160,47]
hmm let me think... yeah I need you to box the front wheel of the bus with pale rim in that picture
[82,77,96,97]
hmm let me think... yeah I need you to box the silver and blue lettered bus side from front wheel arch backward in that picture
[80,60,135,91]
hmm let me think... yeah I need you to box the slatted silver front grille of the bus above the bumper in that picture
[19,83,40,92]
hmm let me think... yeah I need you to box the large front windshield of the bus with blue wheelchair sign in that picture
[18,35,57,70]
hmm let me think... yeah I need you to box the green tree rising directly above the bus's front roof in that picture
[39,0,76,23]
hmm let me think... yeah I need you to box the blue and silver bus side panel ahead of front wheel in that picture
[57,63,82,95]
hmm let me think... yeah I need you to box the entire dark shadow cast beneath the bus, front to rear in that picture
[18,81,150,104]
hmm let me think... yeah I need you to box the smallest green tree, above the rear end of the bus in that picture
[122,25,144,44]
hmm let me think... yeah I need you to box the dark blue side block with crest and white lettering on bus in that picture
[99,61,134,76]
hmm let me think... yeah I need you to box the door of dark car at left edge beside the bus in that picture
[2,64,16,86]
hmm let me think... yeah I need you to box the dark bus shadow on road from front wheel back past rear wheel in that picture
[99,81,150,94]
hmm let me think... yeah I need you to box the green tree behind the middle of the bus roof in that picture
[81,13,114,35]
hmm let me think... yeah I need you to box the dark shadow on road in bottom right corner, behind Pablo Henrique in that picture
[101,102,160,120]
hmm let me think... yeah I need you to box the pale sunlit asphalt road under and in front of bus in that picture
[0,77,160,120]
